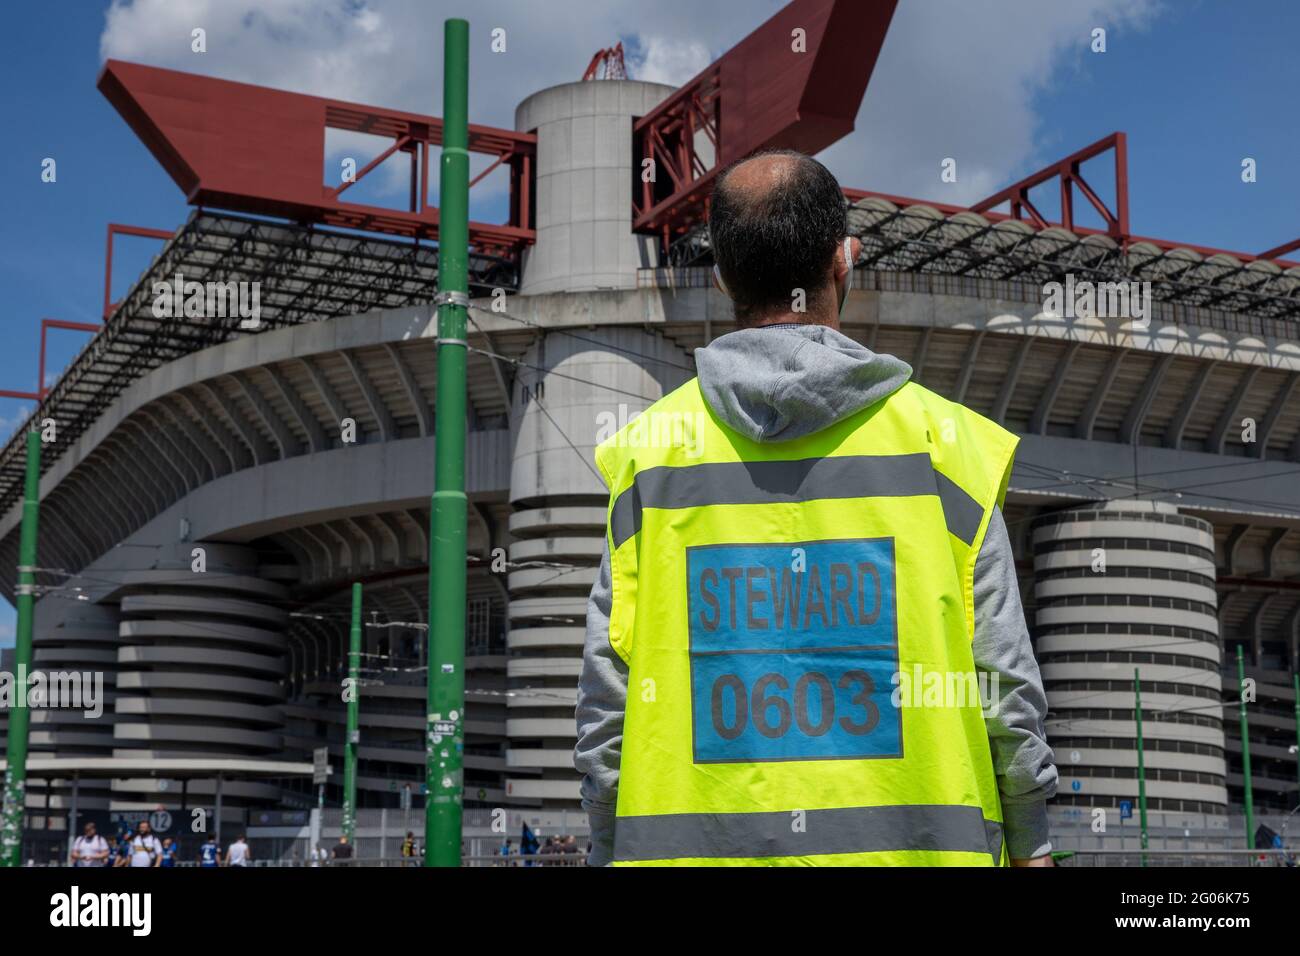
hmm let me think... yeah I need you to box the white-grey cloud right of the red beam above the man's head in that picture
[822,0,1157,206]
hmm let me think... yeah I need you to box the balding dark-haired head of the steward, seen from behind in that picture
[709,150,848,324]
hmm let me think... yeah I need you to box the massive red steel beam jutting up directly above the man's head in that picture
[632,0,897,239]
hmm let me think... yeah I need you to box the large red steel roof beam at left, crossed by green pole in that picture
[99,60,537,252]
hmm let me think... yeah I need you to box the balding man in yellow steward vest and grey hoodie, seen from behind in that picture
[575,151,1057,866]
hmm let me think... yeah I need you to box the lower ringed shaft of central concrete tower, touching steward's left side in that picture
[506,329,689,808]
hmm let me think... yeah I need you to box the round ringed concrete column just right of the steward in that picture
[1031,501,1227,823]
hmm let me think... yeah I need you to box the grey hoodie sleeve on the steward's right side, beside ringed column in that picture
[971,509,1057,860]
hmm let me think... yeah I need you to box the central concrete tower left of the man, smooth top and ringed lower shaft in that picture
[506,81,690,806]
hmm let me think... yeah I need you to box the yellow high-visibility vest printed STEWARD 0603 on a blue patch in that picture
[595,380,1018,866]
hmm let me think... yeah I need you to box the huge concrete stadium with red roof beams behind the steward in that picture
[0,0,1300,853]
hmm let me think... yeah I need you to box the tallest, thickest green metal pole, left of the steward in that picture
[424,20,469,866]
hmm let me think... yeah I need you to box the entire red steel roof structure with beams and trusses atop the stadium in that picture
[0,0,1300,520]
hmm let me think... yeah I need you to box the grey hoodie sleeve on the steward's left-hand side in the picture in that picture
[573,541,628,866]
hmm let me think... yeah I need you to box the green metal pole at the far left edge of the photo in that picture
[0,431,40,866]
